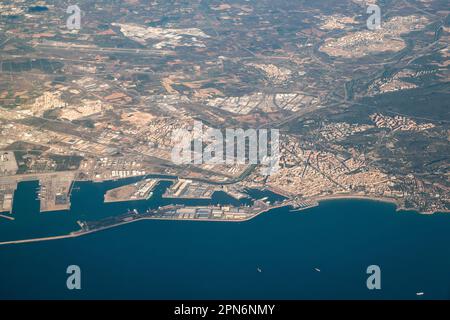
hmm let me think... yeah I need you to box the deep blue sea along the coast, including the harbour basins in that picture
[0,182,450,299]
